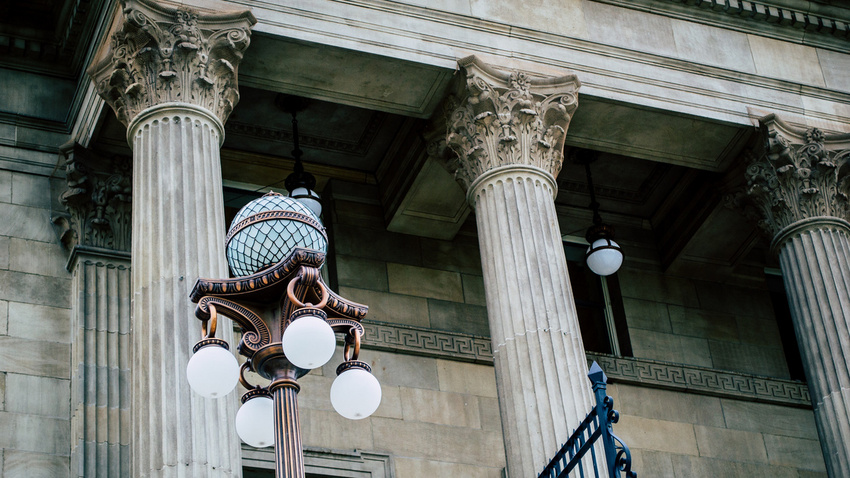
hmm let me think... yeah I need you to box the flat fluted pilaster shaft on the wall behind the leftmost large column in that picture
[71,246,130,478]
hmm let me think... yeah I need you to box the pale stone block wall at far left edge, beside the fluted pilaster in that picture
[0,160,72,478]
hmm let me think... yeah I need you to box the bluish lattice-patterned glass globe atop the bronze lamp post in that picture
[225,193,328,276]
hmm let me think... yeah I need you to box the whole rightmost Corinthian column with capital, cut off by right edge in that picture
[746,115,850,478]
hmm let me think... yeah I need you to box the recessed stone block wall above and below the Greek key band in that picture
[278,180,826,478]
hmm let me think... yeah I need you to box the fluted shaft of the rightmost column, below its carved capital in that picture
[779,218,850,477]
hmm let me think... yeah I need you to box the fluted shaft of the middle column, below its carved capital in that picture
[469,166,593,477]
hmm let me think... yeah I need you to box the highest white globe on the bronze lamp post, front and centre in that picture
[283,315,336,370]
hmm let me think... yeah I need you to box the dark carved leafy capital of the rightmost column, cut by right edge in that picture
[745,115,850,243]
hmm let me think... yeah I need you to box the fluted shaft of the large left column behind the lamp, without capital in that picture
[128,103,241,477]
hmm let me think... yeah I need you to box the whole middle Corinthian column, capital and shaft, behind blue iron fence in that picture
[446,57,593,477]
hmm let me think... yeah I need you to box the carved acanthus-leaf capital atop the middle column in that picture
[446,57,580,189]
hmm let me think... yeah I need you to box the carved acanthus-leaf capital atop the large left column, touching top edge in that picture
[88,0,257,125]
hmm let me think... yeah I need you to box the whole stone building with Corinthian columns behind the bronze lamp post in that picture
[0,0,850,478]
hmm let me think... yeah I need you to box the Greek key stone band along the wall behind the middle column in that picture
[356,320,811,407]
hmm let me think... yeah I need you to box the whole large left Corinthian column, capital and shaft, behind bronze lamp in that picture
[89,0,256,477]
